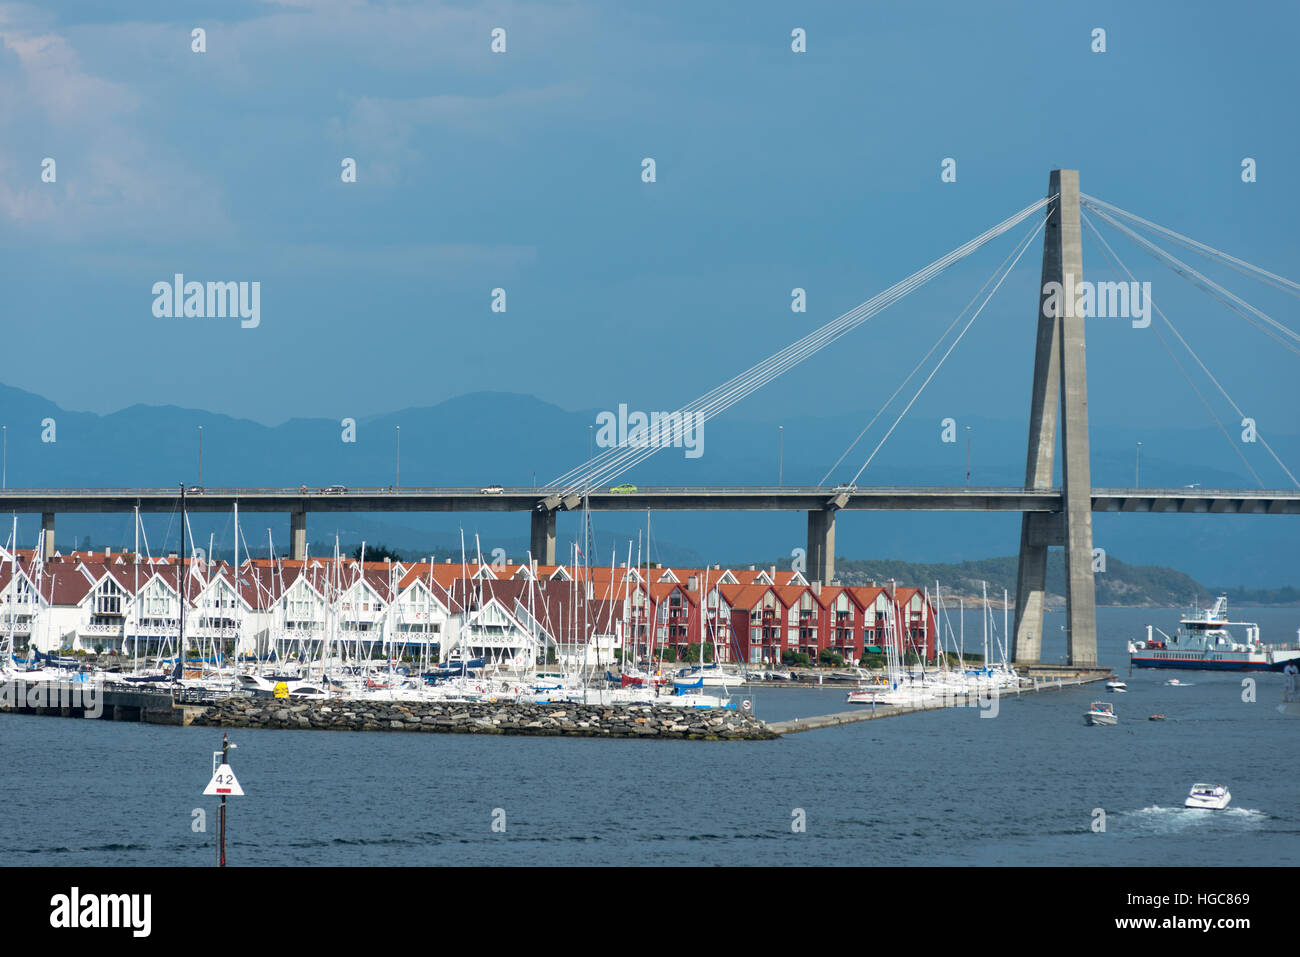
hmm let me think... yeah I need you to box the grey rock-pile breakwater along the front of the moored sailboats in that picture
[187,697,777,741]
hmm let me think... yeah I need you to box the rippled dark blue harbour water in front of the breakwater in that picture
[0,655,1300,866]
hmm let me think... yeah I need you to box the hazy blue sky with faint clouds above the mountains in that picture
[0,0,1300,485]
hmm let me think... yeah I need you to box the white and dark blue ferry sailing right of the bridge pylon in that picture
[1128,596,1300,671]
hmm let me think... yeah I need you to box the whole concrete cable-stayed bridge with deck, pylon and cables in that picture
[0,170,1300,666]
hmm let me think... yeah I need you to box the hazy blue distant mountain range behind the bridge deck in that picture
[0,378,1300,589]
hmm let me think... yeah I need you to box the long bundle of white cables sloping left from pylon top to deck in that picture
[545,196,1054,495]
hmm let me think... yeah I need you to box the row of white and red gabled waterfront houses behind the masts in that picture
[0,549,936,664]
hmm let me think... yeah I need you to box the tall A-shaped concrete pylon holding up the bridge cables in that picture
[1011,169,1097,666]
